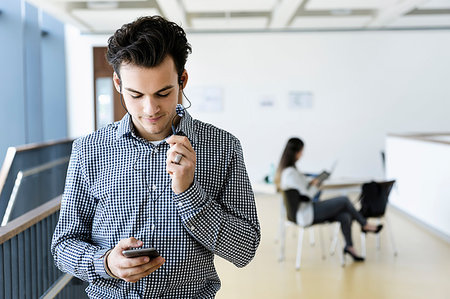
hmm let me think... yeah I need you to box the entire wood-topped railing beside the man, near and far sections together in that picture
[0,140,87,299]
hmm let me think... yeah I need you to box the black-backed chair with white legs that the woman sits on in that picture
[279,189,344,270]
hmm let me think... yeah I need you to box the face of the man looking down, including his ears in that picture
[114,56,187,141]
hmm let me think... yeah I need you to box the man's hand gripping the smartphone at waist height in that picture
[106,237,165,282]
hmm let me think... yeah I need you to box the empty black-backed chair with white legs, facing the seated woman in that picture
[359,180,398,257]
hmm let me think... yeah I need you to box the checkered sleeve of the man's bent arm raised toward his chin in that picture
[174,139,261,267]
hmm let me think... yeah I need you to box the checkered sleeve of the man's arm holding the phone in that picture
[51,141,112,282]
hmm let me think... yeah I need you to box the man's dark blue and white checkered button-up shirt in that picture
[52,105,260,299]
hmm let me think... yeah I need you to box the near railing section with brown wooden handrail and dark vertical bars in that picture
[0,196,86,298]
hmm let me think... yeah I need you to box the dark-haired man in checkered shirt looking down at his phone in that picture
[52,17,260,298]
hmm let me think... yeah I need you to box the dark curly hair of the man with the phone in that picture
[106,16,192,77]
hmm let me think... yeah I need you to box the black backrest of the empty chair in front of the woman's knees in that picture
[359,180,395,217]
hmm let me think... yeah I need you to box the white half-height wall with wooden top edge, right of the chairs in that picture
[386,136,450,240]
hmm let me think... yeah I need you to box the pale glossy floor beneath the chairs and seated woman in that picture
[216,195,450,299]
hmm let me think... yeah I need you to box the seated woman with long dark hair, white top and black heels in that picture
[275,138,383,262]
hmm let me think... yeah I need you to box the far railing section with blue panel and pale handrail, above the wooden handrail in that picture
[0,139,73,225]
